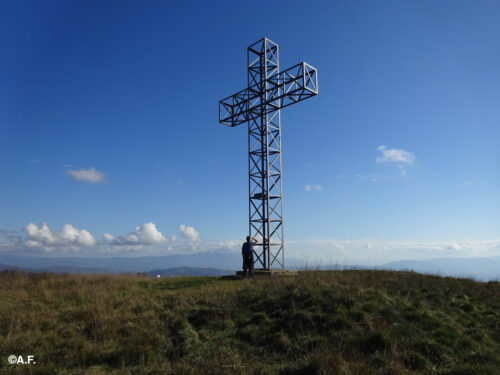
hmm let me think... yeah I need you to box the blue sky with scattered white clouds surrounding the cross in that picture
[0,1,500,263]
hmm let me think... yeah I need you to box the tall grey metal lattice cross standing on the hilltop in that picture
[219,38,318,270]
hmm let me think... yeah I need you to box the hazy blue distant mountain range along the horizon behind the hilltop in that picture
[0,252,500,281]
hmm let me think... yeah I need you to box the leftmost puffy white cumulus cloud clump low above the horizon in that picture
[24,223,97,251]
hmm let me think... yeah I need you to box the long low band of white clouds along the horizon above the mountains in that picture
[0,222,500,265]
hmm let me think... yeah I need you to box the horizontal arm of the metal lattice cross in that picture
[219,62,318,126]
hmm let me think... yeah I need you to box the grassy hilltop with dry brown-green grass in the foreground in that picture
[0,271,500,375]
